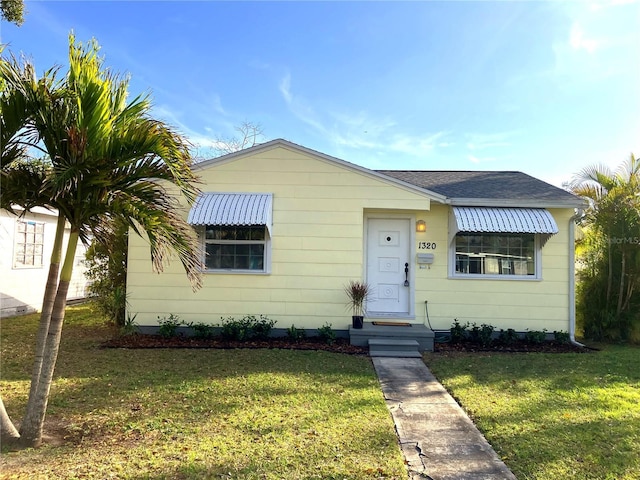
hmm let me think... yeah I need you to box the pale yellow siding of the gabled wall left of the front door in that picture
[127,147,430,329]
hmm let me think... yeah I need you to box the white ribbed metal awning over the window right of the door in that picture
[451,207,558,244]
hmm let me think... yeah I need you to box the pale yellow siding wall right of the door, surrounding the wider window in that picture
[416,204,573,332]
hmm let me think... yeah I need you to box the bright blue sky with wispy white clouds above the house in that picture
[0,0,640,185]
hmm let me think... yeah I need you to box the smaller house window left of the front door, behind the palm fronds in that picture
[204,225,268,272]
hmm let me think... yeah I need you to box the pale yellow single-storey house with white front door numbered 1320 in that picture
[127,140,582,348]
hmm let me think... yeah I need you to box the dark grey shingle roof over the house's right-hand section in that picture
[376,170,580,202]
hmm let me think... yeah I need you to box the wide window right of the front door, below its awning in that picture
[454,233,539,278]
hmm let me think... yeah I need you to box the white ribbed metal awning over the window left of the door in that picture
[187,192,273,234]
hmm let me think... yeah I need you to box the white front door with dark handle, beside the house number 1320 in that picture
[367,218,412,317]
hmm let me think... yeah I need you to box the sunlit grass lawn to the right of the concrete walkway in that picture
[425,346,640,480]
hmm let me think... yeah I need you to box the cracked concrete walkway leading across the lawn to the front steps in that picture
[372,357,516,480]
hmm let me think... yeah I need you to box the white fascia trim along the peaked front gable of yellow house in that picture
[193,139,447,203]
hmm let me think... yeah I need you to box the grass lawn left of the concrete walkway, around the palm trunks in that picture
[0,306,407,479]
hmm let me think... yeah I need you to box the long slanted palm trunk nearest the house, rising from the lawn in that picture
[20,229,78,447]
